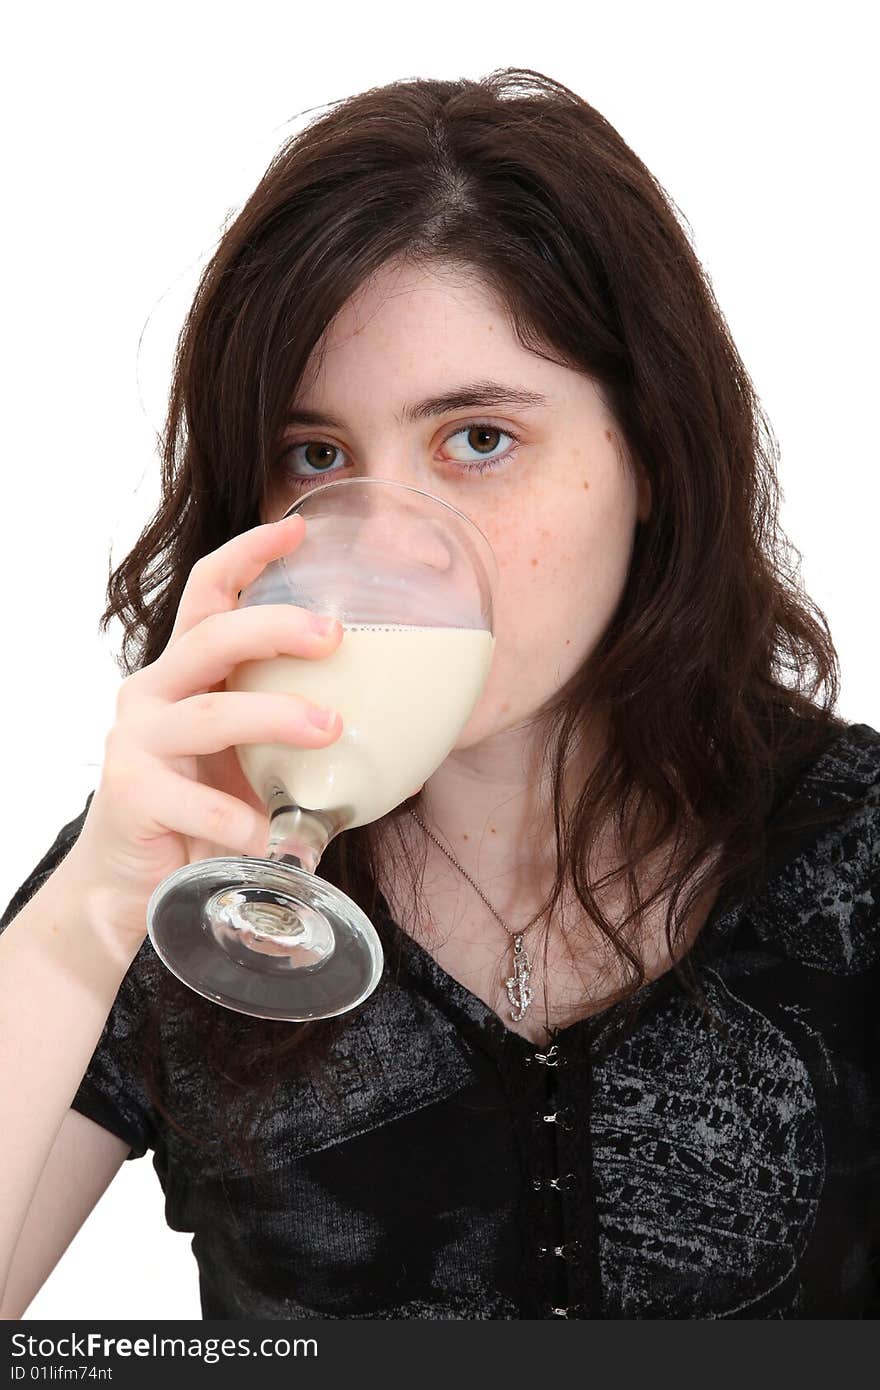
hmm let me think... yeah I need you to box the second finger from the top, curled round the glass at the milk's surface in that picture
[136,603,342,702]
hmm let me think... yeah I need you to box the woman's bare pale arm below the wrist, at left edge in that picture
[0,858,138,1316]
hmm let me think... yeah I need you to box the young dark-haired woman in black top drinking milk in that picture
[0,70,880,1319]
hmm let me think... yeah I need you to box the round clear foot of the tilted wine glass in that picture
[147,855,384,1023]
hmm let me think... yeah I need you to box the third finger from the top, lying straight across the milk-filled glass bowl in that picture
[140,691,341,759]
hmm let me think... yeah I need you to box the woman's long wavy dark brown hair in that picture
[101,68,845,1175]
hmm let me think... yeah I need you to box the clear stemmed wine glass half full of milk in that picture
[147,478,498,1020]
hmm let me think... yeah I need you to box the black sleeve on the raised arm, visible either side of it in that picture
[0,792,160,1159]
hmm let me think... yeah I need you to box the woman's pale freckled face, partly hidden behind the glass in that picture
[257,264,651,749]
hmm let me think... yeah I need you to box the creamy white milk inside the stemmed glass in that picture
[225,623,495,828]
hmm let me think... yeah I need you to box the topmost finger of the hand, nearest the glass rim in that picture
[168,512,306,646]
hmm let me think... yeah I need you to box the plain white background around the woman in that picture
[0,0,880,1319]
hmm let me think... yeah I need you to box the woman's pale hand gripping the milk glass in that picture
[67,514,342,945]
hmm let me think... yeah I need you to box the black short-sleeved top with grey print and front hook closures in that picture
[0,724,880,1319]
